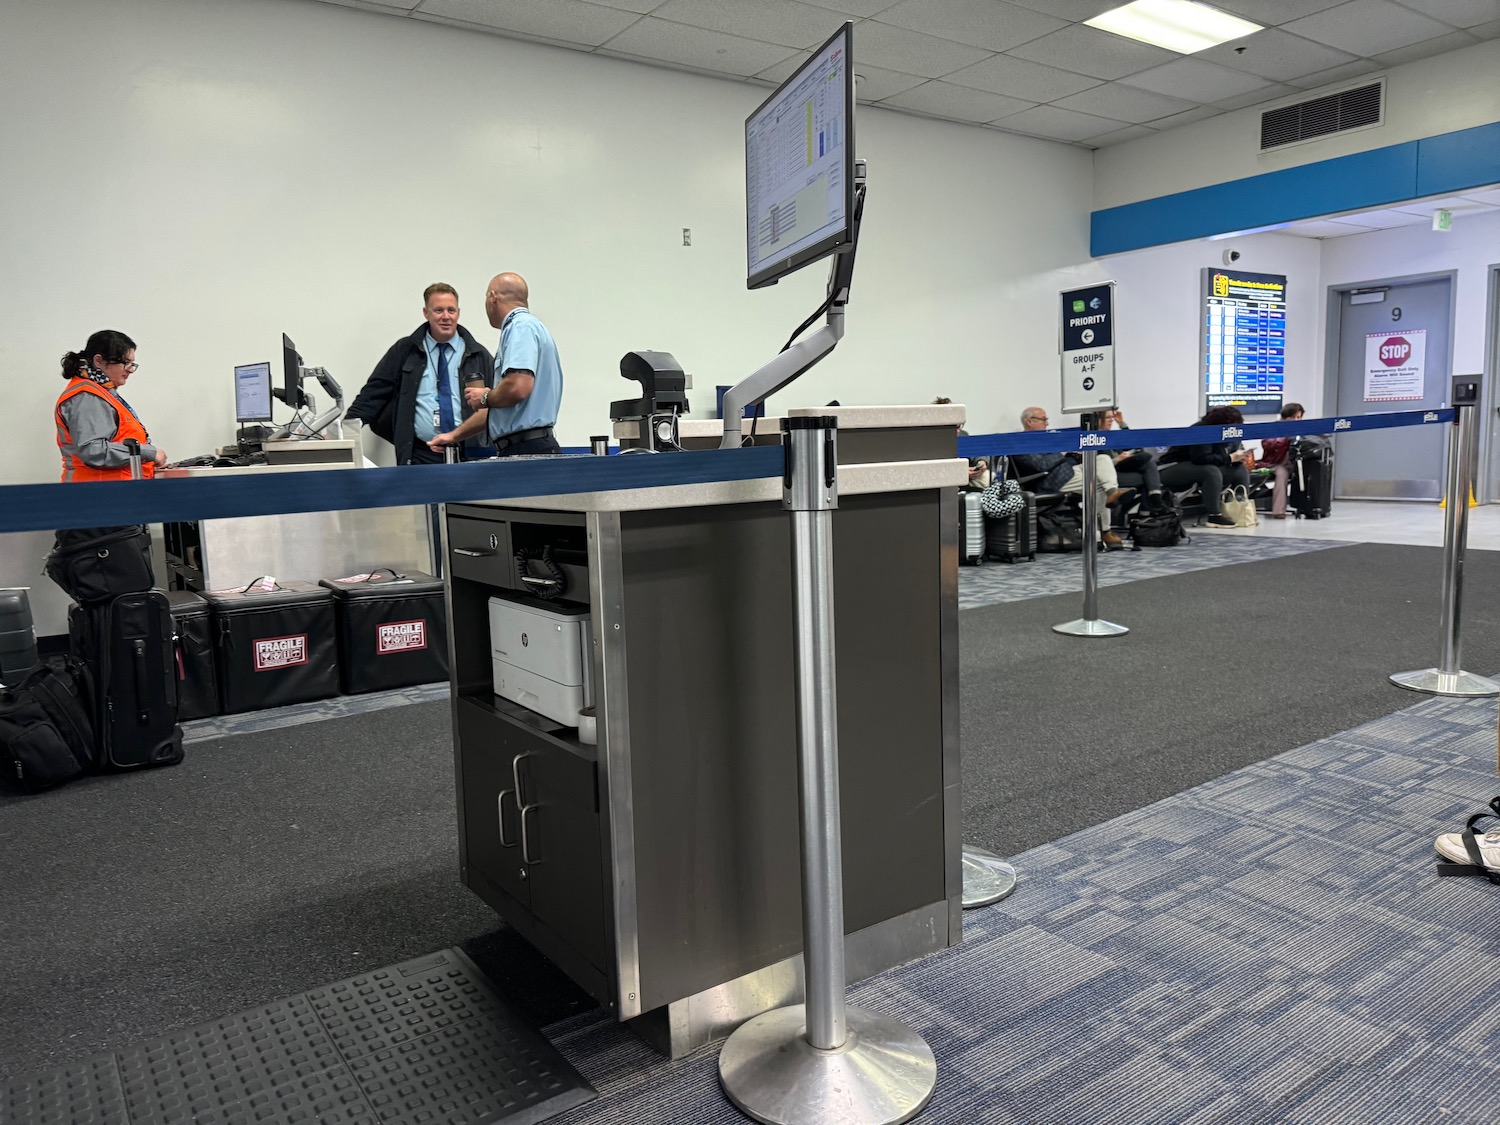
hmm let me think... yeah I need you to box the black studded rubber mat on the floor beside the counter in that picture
[0,950,596,1125]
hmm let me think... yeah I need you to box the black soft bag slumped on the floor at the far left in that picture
[0,660,95,794]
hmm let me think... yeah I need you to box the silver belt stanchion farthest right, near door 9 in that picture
[1391,375,1500,696]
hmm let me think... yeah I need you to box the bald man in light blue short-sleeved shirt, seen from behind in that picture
[429,273,563,458]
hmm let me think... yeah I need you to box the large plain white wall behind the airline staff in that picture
[0,0,1091,482]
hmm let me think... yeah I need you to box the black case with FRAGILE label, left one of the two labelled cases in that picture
[204,582,339,714]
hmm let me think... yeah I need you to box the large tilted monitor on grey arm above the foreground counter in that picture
[746,23,855,290]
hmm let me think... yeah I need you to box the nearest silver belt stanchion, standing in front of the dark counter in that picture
[719,417,938,1125]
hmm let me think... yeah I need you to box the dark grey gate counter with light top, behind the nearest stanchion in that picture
[444,407,968,1058]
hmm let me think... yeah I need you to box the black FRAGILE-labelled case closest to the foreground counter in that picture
[320,570,449,695]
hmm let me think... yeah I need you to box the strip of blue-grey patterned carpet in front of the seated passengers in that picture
[959,533,1350,609]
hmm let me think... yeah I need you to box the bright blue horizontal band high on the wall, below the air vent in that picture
[1089,123,1500,258]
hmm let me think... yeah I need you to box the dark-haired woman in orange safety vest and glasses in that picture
[54,329,167,480]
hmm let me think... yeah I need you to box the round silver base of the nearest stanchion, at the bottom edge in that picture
[719,1004,938,1125]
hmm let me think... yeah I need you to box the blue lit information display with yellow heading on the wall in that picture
[1203,269,1287,414]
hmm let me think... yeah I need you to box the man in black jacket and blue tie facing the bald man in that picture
[344,282,495,465]
